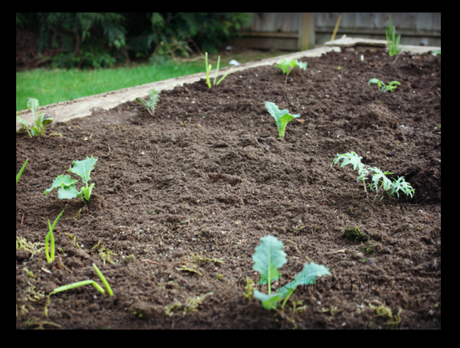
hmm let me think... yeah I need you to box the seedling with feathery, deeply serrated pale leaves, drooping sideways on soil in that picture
[331,151,415,201]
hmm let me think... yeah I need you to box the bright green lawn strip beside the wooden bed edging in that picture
[16,51,289,111]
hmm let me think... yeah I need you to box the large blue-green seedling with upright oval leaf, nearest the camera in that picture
[252,236,331,309]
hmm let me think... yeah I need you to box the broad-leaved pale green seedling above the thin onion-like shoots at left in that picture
[45,156,97,204]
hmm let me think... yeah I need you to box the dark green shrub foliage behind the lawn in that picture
[16,12,253,68]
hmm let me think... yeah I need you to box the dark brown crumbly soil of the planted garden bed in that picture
[16,50,441,329]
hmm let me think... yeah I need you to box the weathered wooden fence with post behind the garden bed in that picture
[229,12,441,51]
